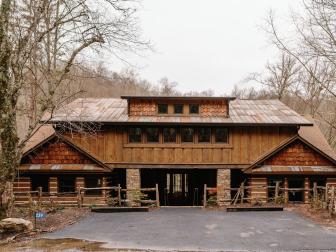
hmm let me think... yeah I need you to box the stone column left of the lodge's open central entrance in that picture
[126,169,141,206]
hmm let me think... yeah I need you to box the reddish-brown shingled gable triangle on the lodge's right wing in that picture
[264,140,334,166]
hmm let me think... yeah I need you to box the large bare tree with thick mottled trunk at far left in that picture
[0,0,149,215]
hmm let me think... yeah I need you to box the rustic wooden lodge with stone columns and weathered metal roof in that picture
[13,96,336,206]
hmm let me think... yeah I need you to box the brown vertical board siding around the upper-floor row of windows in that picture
[64,126,297,164]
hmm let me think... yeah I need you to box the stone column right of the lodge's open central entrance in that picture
[217,169,231,206]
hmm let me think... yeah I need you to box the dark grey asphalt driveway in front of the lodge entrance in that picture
[45,208,336,251]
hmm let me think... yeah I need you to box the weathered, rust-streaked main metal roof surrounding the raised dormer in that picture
[51,97,313,125]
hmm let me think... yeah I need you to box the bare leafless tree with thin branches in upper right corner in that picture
[267,0,336,144]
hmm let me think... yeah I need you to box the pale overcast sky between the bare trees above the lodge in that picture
[105,0,301,95]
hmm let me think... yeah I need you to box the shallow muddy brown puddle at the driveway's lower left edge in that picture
[0,238,114,252]
